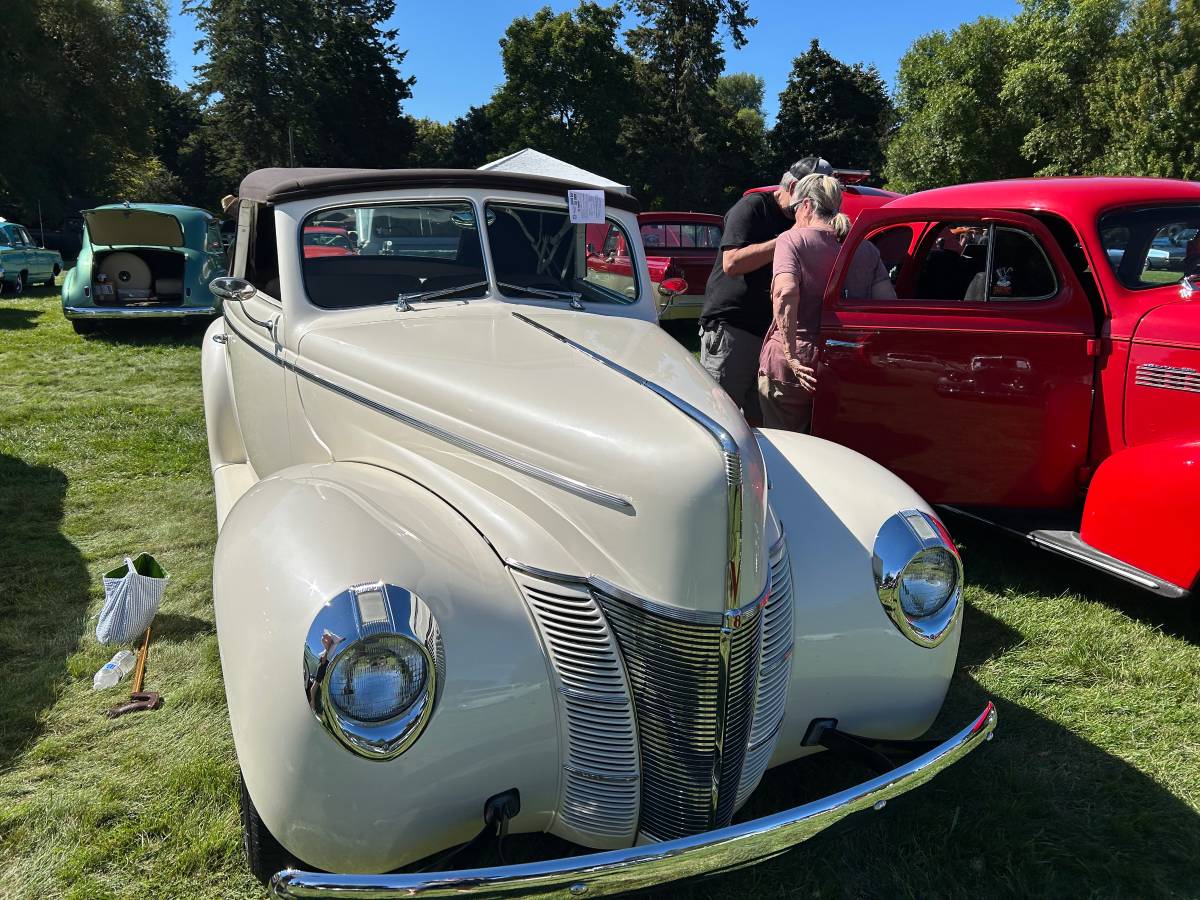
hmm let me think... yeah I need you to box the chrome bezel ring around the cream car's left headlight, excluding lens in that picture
[304,582,445,760]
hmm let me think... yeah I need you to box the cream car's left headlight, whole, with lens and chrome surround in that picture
[304,583,445,760]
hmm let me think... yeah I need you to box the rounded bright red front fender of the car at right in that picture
[1079,440,1200,590]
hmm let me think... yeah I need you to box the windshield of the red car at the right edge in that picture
[1100,206,1200,288]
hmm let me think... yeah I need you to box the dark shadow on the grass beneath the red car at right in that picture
[947,514,1200,644]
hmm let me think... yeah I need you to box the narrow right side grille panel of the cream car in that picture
[737,538,794,806]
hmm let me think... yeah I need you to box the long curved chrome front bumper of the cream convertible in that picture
[271,703,996,900]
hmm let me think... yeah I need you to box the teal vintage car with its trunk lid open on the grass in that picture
[62,203,227,334]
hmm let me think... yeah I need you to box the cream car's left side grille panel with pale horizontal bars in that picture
[514,572,638,846]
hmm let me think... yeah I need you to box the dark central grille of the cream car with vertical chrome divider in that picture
[593,588,761,840]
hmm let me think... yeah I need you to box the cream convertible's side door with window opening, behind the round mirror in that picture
[222,202,292,478]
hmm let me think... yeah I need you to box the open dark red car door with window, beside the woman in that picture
[812,208,1098,508]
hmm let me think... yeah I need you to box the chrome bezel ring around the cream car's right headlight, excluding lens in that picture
[871,509,962,648]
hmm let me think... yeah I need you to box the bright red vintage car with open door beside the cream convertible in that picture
[812,178,1200,598]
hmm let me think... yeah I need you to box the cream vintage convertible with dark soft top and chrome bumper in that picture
[203,169,995,898]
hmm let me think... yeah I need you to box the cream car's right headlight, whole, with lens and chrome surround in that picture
[872,510,962,647]
